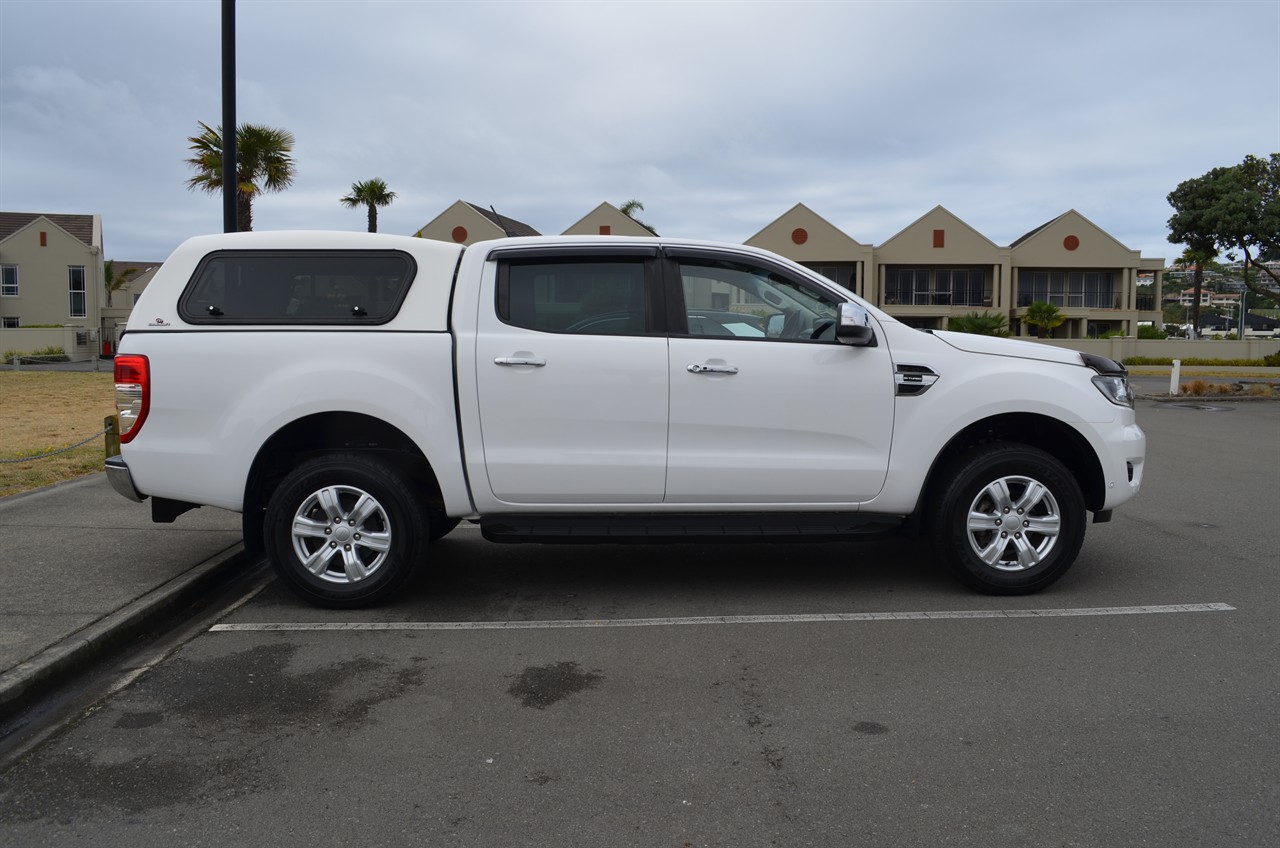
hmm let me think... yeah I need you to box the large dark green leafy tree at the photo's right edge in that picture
[1169,154,1280,302]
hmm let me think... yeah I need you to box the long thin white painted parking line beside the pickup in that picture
[210,603,1235,633]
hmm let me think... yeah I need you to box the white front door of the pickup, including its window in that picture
[666,251,895,505]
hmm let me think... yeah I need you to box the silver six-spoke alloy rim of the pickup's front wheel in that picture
[969,477,1062,571]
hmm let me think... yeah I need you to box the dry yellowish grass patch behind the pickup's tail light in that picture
[0,370,115,497]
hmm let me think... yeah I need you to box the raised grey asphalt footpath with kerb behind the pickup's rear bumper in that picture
[0,474,244,724]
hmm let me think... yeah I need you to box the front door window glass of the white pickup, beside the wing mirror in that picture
[680,259,838,341]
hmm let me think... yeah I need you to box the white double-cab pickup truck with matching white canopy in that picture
[106,232,1146,607]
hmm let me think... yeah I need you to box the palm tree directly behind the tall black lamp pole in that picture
[187,122,293,232]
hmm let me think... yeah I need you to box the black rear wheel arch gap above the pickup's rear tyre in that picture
[242,411,443,555]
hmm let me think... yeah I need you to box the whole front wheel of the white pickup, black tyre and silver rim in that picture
[929,442,1085,594]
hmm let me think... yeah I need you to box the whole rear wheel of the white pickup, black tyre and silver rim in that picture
[264,453,429,607]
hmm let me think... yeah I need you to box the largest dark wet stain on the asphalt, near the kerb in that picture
[0,644,429,824]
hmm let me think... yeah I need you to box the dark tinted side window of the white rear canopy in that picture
[178,250,415,325]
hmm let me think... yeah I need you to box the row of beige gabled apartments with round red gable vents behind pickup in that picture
[417,200,1165,338]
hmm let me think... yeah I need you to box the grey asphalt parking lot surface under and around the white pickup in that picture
[0,402,1280,848]
